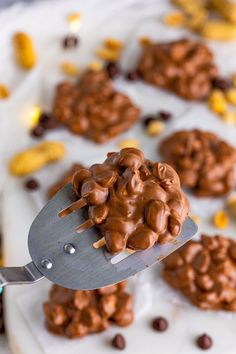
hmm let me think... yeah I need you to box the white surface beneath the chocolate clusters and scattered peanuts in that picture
[0,0,236,354]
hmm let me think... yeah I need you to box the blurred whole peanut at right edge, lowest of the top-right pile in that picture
[201,20,236,41]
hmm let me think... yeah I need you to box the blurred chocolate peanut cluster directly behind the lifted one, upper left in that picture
[53,70,140,143]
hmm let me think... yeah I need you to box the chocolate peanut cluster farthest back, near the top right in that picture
[137,39,218,100]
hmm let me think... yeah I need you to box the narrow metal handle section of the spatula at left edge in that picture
[0,262,44,287]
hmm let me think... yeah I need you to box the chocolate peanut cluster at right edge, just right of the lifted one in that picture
[160,130,236,197]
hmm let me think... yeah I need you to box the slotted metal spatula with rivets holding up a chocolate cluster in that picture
[0,184,197,290]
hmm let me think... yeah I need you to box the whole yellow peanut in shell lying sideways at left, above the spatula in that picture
[9,141,65,176]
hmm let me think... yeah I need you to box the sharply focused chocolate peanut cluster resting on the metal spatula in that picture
[73,148,189,253]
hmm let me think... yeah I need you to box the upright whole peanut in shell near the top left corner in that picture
[13,32,37,70]
